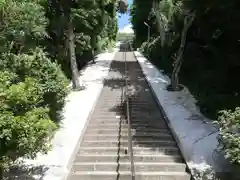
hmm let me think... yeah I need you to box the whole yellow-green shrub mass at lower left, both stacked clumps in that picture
[0,70,56,172]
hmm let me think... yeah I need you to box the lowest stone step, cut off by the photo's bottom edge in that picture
[70,171,190,180]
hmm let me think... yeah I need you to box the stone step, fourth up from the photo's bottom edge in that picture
[78,146,180,155]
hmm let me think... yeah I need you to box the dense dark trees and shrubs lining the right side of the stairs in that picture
[131,0,240,169]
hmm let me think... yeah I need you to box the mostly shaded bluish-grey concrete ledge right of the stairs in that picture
[134,51,229,179]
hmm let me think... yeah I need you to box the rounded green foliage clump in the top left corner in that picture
[0,0,48,53]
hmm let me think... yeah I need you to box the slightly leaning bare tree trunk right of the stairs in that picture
[171,12,195,91]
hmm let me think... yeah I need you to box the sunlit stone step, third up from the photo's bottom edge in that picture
[75,153,182,163]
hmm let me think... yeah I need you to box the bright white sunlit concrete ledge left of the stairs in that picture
[9,52,115,180]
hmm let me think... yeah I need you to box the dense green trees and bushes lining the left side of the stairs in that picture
[0,0,127,178]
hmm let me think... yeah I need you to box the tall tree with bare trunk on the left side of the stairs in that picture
[45,0,127,90]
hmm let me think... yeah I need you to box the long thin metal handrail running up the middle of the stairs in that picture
[124,44,135,180]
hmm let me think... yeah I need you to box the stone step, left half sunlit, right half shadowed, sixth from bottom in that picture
[83,133,173,141]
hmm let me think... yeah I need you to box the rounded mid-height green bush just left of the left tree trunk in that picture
[0,48,68,119]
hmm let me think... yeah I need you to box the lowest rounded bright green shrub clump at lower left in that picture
[0,108,56,169]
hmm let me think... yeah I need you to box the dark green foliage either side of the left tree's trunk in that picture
[47,0,122,77]
